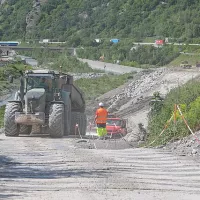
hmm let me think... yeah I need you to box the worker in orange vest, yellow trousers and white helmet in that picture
[95,102,108,139]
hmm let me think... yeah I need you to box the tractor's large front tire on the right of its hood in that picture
[49,104,65,138]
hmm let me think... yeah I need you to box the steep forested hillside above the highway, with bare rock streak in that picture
[0,0,200,43]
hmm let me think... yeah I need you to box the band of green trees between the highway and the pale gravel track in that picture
[77,43,179,68]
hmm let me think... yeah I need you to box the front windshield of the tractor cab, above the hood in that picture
[26,74,53,91]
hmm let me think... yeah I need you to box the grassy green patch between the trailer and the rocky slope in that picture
[75,73,131,100]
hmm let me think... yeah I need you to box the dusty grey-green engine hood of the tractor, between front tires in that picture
[25,88,46,113]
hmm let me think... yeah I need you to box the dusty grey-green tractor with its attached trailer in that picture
[4,70,87,137]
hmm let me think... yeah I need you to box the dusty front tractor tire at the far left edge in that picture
[4,102,21,137]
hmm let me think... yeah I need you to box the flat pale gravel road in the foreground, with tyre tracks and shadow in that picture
[0,135,200,200]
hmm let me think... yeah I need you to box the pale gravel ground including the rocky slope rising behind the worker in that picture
[0,61,200,200]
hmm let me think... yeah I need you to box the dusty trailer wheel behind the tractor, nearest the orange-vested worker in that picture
[71,112,87,136]
